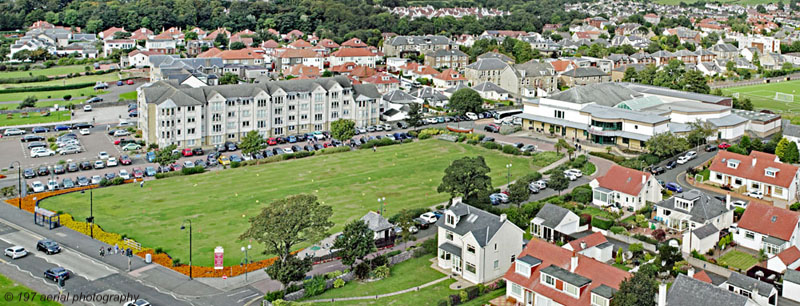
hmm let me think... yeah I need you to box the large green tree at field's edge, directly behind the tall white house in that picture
[436,156,492,198]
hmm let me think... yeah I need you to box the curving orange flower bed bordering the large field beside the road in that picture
[6,186,290,277]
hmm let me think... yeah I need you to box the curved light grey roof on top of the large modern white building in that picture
[549,83,642,106]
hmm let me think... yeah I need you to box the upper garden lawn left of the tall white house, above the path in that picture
[308,256,447,300]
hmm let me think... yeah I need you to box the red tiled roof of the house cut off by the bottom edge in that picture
[503,238,631,305]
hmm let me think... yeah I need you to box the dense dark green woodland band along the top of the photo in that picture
[0,0,585,44]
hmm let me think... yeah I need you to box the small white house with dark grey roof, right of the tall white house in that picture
[530,203,588,242]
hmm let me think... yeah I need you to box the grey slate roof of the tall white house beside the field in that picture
[436,202,509,247]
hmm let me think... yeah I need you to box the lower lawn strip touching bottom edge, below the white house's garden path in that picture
[325,279,457,306]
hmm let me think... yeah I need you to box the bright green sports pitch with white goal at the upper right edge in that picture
[722,80,800,124]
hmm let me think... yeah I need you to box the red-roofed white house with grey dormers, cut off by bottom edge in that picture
[503,239,631,306]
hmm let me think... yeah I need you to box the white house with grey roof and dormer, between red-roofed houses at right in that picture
[653,189,733,232]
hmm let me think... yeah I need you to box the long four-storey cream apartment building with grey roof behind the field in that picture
[137,77,381,148]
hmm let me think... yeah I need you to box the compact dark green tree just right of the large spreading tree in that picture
[333,220,375,268]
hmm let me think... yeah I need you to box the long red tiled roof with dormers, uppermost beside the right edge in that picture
[709,151,798,188]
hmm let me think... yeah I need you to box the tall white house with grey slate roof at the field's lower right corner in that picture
[436,202,524,284]
